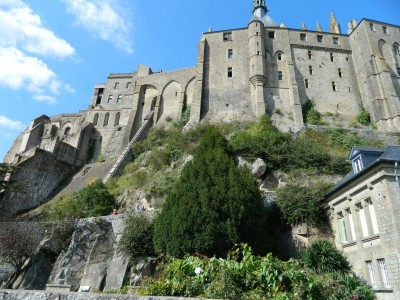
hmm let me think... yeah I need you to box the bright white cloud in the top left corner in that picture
[0,0,75,58]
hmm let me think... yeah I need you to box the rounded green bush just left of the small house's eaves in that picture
[276,181,334,225]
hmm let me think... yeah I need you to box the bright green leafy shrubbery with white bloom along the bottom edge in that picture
[140,245,375,300]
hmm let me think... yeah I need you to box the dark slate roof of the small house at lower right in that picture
[325,146,400,198]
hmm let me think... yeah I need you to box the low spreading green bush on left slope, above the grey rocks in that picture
[49,180,118,221]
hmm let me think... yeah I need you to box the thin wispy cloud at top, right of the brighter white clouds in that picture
[63,0,133,53]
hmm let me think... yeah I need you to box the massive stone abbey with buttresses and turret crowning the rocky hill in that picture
[0,0,400,216]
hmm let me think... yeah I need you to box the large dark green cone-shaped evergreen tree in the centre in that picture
[154,126,266,257]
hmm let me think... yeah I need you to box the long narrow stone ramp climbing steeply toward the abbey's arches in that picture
[103,111,154,183]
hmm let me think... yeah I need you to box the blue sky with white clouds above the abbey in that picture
[0,0,400,160]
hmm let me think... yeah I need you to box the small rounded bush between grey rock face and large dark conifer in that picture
[118,213,155,261]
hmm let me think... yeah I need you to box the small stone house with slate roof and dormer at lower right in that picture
[326,146,400,299]
